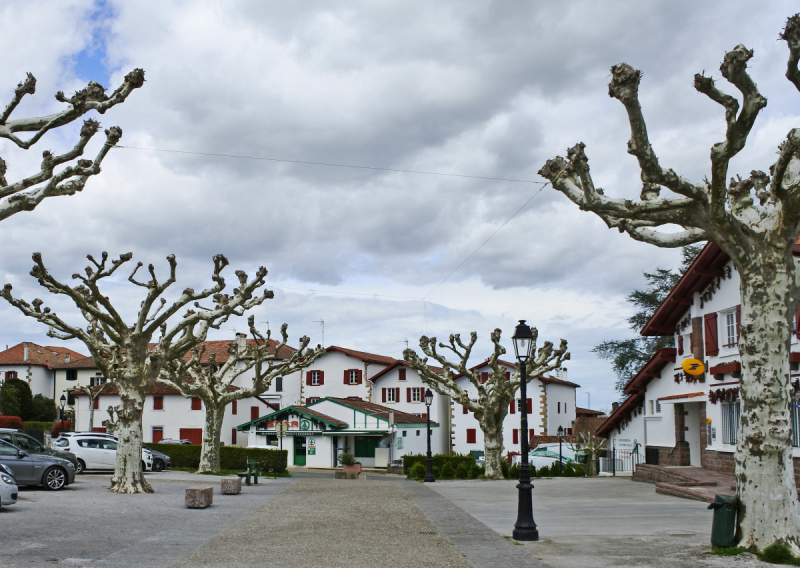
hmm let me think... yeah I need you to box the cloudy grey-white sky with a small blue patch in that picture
[0,0,800,408]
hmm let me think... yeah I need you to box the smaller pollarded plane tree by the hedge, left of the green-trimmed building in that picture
[159,315,325,472]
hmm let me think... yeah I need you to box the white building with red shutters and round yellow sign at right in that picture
[597,243,800,475]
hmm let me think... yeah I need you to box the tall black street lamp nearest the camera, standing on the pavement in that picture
[511,320,539,540]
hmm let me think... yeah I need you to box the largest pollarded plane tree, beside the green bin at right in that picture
[540,14,800,551]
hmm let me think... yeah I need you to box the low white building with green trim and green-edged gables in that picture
[238,397,439,468]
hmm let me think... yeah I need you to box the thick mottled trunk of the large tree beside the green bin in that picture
[735,253,800,551]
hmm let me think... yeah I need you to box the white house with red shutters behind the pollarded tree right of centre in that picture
[450,359,580,456]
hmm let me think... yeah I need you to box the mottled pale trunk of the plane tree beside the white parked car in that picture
[109,384,153,493]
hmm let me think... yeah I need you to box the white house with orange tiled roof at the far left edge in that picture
[0,341,86,401]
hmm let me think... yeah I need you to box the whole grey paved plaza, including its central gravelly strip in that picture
[0,472,768,568]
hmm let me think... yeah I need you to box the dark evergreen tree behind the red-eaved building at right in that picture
[592,244,703,392]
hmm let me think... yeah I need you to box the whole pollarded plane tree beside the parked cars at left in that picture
[2,252,273,493]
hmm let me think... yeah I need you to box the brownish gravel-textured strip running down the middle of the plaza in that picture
[173,479,470,568]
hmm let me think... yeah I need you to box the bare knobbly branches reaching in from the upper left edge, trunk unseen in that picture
[0,69,144,221]
